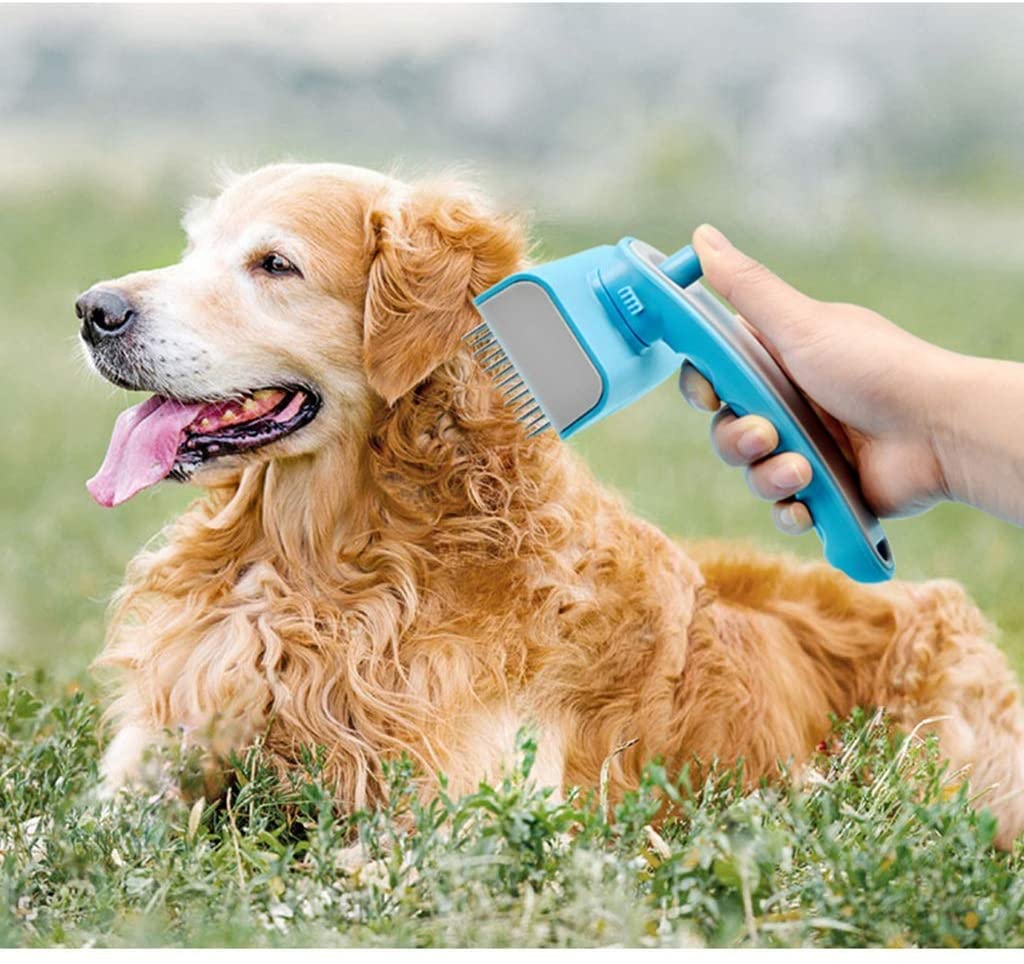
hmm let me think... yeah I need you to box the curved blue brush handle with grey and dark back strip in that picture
[618,238,894,582]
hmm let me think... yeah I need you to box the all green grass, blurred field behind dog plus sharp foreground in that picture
[0,185,1024,945]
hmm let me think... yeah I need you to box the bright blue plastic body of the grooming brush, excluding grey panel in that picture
[477,238,894,582]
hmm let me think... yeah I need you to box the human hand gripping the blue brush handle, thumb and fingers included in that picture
[680,224,961,534]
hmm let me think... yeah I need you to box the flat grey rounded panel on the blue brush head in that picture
[477,280,604,432]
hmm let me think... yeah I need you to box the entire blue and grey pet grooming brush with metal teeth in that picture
[467,238,893,582]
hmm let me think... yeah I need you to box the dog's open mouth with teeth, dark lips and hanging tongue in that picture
[86,386,321,508]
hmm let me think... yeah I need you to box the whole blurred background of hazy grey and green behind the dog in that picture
[0,4,1024,680]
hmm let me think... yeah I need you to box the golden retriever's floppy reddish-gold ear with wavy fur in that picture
[362,183,525,404]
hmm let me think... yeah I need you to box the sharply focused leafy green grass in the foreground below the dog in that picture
[0,677,1024,947]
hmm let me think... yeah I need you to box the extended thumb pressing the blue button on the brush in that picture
[693,224,815,351]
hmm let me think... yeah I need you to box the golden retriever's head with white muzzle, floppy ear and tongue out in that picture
[76,165,524,506]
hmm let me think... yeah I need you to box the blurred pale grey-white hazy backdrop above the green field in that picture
[0,4,1024,260]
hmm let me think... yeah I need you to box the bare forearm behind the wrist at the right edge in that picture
[932,354,1024,525]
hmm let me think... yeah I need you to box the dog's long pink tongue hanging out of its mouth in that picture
[85,395,204,508]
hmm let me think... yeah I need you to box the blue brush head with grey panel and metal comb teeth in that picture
[467,245,682,437]
